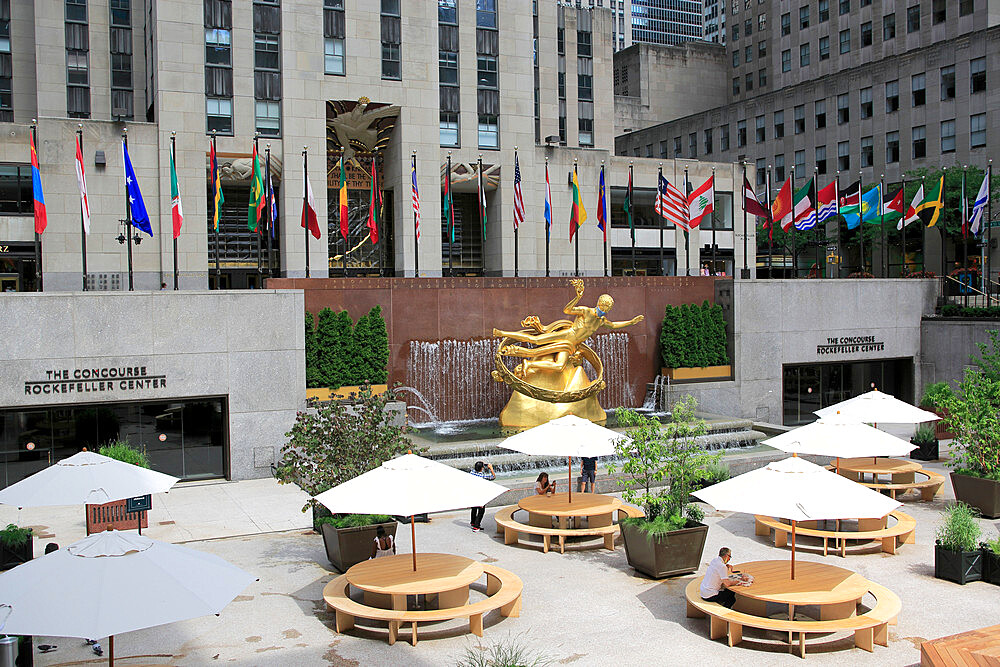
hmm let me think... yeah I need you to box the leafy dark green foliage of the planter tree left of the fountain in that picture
[274,385,410,512]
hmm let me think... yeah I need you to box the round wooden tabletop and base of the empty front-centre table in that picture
[344,553,485,610]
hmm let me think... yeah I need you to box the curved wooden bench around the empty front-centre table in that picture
[323,563,524,646]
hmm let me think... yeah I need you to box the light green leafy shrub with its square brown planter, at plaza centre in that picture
[609,396,719,579]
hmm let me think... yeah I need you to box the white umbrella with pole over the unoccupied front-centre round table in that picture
[316,454,507,571]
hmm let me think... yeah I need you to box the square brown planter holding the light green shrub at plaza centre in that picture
[621,521,708,579]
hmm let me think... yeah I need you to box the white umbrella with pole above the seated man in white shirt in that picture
[692,457,901,579]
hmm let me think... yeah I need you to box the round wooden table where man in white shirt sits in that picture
[729,560,870,620]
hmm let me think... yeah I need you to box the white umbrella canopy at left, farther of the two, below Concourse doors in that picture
[0,452,177,507]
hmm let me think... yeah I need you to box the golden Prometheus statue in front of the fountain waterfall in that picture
[492,280,643,428]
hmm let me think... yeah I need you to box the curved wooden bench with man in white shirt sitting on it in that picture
[684,580,903,658]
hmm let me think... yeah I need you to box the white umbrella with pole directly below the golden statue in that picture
[500,415,622,502]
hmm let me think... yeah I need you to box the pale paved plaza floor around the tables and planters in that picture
[13,464,1000,666]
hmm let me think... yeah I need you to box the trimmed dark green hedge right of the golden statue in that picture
[660,301,729,368]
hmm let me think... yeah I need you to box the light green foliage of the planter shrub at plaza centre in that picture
[608,396,721,531]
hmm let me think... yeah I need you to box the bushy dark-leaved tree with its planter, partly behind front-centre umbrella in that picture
[275,385,410,572]
